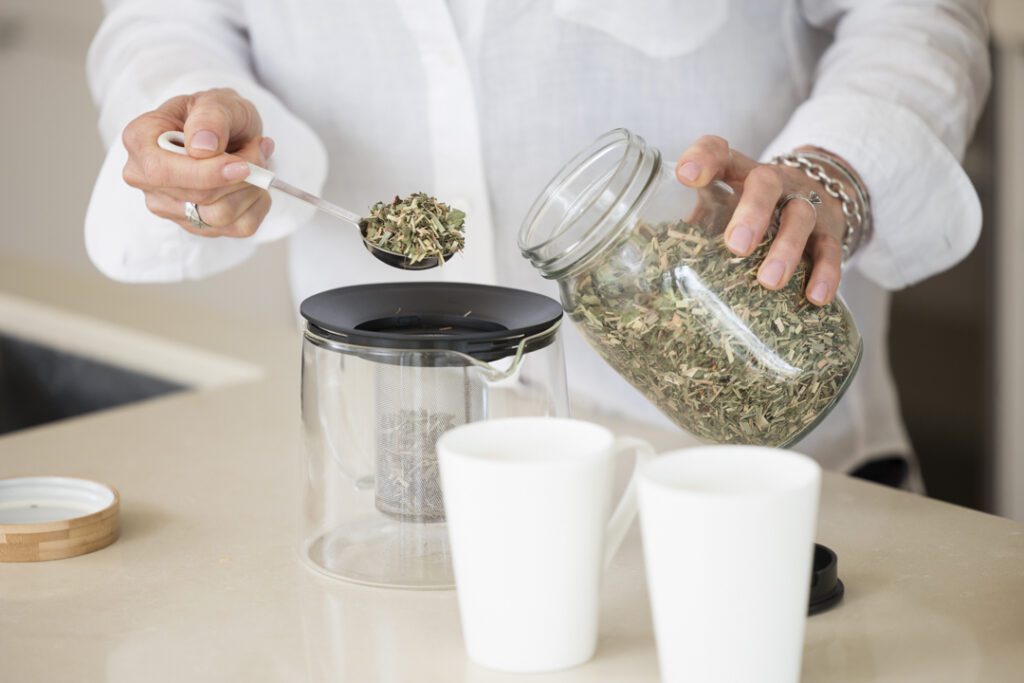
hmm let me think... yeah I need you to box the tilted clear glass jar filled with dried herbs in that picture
[519,129,861,446]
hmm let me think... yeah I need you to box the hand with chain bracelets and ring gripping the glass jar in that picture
[676,135,868,306]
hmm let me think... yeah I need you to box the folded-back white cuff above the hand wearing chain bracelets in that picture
[762,95,981,290]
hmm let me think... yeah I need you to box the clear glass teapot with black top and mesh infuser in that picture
[300,283,568,589]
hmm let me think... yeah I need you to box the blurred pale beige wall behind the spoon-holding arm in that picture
[0,0,295,326]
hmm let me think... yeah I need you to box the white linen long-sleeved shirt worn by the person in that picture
[85,0,989,479]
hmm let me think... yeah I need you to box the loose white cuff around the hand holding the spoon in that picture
[85,71,328,282]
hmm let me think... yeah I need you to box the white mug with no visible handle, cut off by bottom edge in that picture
[637,445,821,683]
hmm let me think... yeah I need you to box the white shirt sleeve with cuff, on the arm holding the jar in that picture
[764,0,991,289]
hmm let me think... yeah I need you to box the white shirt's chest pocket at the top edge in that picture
[554,0,729,59]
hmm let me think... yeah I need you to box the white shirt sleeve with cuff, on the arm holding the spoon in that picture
[85,0,327,282]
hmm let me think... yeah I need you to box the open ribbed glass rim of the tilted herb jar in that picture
[517,128,662,279]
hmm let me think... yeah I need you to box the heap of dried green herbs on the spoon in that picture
[359,193,466,263]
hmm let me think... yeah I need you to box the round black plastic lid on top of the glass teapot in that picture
[299,283,562,360]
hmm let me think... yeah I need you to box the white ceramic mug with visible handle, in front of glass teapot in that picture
[437,418,653,673]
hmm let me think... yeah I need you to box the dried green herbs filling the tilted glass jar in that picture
[568,222,861,445]
